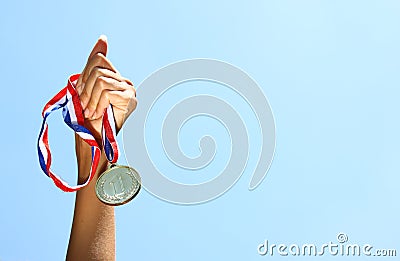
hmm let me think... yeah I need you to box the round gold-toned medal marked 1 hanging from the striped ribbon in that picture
[96,164,141,206]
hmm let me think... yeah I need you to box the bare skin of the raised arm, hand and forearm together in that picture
[66,36,137,260]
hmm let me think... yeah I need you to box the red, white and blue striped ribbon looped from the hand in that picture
[38,74,118,192]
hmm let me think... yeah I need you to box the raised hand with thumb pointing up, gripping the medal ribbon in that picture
[76,36,137,142]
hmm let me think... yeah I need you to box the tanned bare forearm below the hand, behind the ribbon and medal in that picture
[67,137,115,260]
